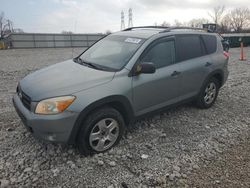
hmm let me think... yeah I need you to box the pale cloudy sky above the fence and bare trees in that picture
[0,0,250,33]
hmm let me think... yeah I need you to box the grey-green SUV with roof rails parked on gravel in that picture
[13,27,229,155]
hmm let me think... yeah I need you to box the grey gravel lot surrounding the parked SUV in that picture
[0,48,250,188]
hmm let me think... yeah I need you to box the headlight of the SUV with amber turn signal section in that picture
[35,96,76,114]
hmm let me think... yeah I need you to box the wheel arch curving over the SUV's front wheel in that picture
[68,95,134,144]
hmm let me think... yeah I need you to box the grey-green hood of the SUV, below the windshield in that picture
[20,60,115,101]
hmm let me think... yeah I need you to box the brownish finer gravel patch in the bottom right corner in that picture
[188,135,250,188]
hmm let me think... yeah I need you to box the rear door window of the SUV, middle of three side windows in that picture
[176,35,205,62]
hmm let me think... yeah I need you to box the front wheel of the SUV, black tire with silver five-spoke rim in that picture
[77,107,125,155]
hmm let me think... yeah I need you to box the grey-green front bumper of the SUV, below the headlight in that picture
[13,94,79,143]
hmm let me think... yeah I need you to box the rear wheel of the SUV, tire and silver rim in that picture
[196,77,220,109]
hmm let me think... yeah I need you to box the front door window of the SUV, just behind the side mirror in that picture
[141,41,175,68]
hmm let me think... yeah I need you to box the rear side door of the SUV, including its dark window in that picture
[176,34,212,99]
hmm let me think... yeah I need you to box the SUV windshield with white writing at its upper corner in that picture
[80,35,144,70]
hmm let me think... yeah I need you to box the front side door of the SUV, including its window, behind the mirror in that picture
[132,37,181,115]
